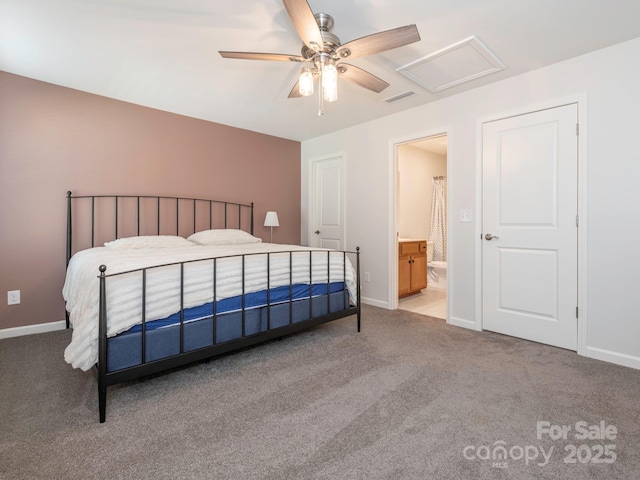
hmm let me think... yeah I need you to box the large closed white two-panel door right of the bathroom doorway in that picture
[482,104,578,350]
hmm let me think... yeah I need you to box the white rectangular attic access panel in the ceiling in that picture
[396,36,505,93]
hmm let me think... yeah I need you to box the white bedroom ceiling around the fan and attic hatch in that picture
[0,0,640,141]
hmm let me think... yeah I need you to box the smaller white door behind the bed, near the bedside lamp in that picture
[309,157,344,250]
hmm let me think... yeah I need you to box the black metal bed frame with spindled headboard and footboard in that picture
[66,192,361,423]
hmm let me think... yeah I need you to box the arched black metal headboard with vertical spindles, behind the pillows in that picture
[67,192,253,265]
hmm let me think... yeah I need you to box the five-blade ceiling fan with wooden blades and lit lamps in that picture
[219,0,420,115]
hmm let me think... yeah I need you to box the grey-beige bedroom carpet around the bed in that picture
[0,306,640,480]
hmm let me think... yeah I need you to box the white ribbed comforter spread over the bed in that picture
[62,243,356,370]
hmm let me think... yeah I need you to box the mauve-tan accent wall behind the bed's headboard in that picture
[0,72,300,329]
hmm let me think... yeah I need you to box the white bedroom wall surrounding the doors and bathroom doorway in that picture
[301,39,640,368]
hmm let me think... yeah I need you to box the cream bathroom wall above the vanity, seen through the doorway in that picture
[397,144,447,240]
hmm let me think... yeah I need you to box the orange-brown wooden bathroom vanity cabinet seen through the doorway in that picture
[398,239,427,297]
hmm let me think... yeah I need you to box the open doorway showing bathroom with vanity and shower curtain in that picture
[396,133,448,319]
